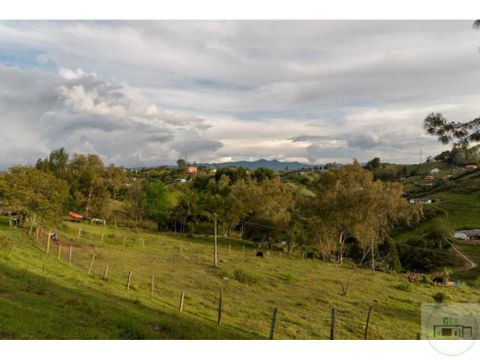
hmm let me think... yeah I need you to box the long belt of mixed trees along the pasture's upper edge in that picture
[0,149,421,270]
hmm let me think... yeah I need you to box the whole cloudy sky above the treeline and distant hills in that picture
[0,21,480,168]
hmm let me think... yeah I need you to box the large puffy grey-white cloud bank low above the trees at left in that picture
[0,67,221,167]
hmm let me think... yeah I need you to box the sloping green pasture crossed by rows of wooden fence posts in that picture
[0,221,480,339]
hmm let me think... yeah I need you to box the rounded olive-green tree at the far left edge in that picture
[0,166,68,222]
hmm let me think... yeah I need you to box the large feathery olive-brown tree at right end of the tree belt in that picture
[306,162,421,273]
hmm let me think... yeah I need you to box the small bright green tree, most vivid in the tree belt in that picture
[143,181,173,230]
